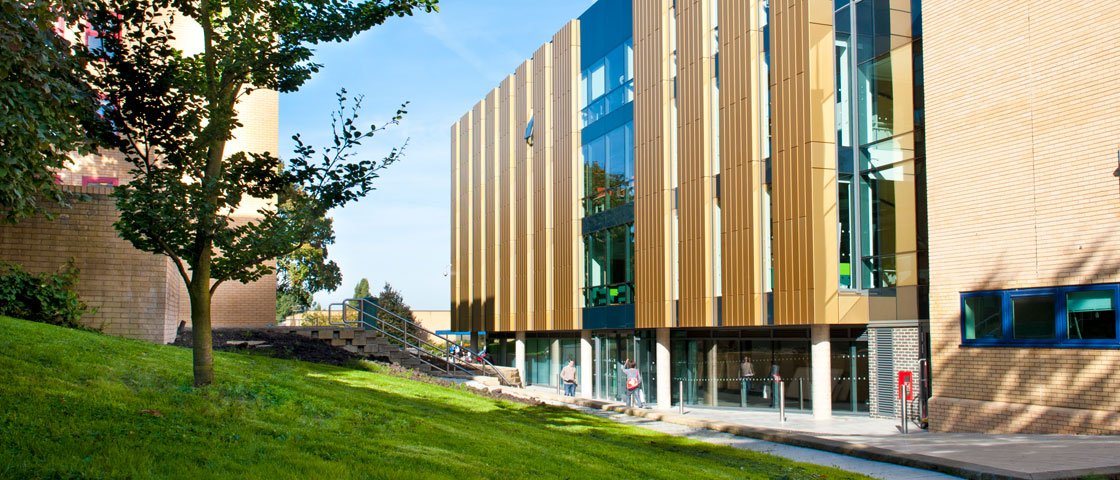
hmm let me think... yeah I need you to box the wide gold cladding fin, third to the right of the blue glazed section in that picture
[718,0,767,327]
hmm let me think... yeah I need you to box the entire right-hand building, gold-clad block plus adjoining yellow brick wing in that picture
[450,0,1120,433]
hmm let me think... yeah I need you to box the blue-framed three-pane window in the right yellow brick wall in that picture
[961,284,1120,348]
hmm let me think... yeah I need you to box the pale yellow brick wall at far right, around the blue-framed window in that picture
[923,0,1120,433]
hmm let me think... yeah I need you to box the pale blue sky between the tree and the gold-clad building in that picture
[280,0,594,310]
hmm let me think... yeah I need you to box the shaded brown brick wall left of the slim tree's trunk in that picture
[0,187,179,342]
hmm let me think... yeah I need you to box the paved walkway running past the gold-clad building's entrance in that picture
[502,387,1120,480]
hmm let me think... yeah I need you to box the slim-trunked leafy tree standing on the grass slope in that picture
[90,0,437,386]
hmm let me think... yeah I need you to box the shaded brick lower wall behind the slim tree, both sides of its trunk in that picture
[0,186,276,343]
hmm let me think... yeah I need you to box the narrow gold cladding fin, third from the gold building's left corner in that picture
[469,100,486,331]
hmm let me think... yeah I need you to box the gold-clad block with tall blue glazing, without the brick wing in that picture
[451,0,928,417]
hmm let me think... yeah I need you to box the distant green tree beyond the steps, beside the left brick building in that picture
[277,213,343,321]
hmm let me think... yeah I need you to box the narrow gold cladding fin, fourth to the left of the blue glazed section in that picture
[494,75,516,331]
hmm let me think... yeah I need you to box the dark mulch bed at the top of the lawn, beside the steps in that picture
[171,328,371,366]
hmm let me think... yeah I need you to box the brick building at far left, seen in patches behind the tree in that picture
[0,18,280,343]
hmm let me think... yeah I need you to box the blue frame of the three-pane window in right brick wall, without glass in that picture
[958,283,1120,349]
